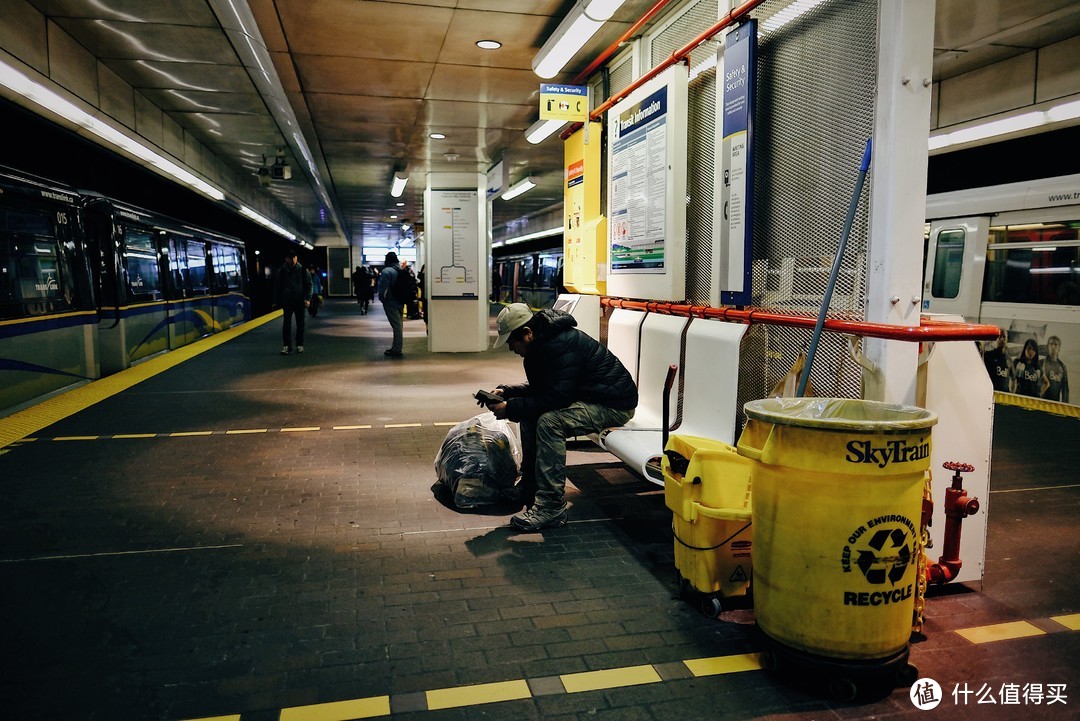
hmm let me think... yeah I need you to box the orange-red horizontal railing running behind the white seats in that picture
[600,296,999,342]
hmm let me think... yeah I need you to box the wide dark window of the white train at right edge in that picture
[983,221,1080,305]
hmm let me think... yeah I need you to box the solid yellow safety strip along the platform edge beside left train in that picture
[0,311,281,448]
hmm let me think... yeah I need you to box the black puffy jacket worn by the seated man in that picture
[499,310,637,421]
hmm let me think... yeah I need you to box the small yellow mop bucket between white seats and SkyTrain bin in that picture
[662,435,753,616]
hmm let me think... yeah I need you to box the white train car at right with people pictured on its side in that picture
[922,175,1080,405]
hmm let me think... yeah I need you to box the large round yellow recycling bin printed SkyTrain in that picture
[739,398,937,661]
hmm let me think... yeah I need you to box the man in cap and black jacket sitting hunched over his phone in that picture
[488,303,637,532]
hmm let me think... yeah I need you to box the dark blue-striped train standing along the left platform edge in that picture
[0,162,251,413]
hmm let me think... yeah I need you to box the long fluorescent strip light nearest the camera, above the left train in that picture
[0,55,225,201]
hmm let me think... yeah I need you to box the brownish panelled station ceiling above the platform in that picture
[21,0,1080,243]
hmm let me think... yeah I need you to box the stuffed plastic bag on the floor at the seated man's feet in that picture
[431,411,521,509]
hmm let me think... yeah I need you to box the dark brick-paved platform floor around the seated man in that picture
[0,301,1080,721]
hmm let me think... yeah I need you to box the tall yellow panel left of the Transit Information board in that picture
[563,123,608,295]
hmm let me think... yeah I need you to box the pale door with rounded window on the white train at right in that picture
[922,216,989,321]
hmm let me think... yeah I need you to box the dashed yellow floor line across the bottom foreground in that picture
[170,613,1080,721]
